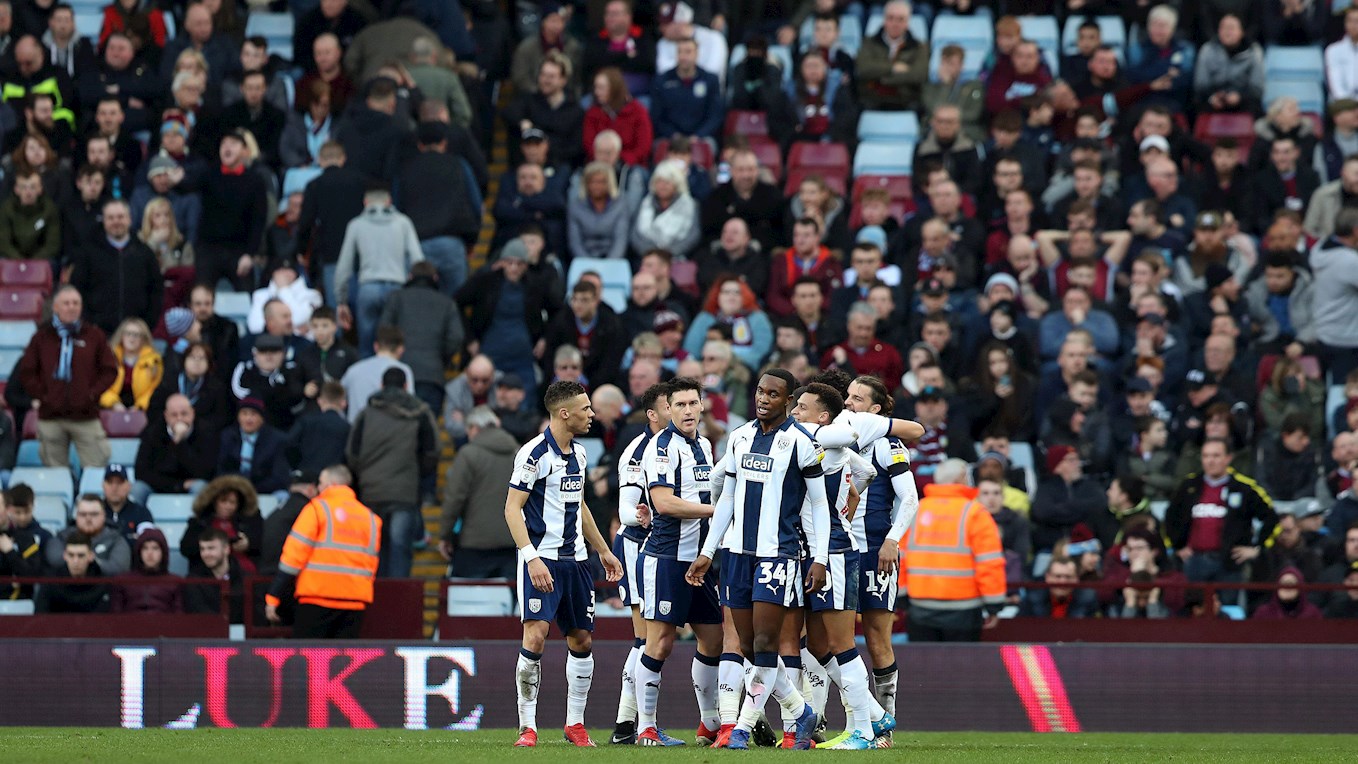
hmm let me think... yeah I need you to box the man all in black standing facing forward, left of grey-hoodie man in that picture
[181,130,269,289]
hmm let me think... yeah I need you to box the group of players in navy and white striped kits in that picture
[505,369,923,749]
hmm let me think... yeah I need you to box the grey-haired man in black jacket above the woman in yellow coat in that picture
[71,199,164,334]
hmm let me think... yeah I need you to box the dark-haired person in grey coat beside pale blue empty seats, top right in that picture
[1194,14,1264,114]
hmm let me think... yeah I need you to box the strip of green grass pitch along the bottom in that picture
[0,727,1358,764]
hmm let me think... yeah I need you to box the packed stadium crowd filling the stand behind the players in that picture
[0,0,1358,619]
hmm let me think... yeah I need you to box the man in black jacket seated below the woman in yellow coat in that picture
[135,390,219,505]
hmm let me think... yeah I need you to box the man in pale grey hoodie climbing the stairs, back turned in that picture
[335,190,424,358]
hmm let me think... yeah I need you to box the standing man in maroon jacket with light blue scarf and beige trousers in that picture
[16,285,118,467]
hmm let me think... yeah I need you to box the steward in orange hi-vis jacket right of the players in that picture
[900,472,1005,642]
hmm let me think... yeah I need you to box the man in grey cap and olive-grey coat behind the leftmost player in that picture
[439,406,519,578]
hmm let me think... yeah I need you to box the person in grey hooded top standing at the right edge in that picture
[1310,208,1358,381]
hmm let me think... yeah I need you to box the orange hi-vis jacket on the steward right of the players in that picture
[900,484,1005,611]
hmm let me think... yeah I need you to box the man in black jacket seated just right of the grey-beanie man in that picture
[542,281,629,389]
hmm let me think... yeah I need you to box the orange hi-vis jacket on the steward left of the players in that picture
[270,486,382,611]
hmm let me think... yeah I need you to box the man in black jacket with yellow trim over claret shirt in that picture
[1162,438,1278,581]
